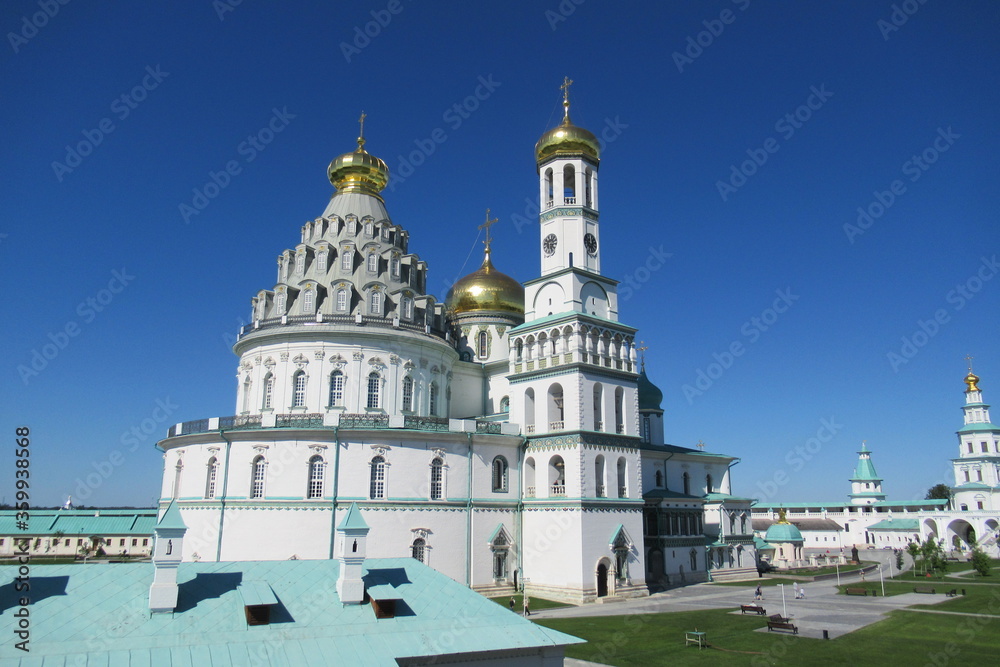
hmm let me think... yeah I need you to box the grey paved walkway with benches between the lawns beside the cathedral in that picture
[531,564,960,640]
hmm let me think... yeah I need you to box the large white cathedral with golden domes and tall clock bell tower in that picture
[158,82,756,602]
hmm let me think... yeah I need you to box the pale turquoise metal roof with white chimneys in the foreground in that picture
[0,558,582,667]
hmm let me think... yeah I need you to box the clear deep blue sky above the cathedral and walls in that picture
[0,0,1000,505]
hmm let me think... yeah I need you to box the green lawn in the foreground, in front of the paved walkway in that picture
[537,609,1000,667]
